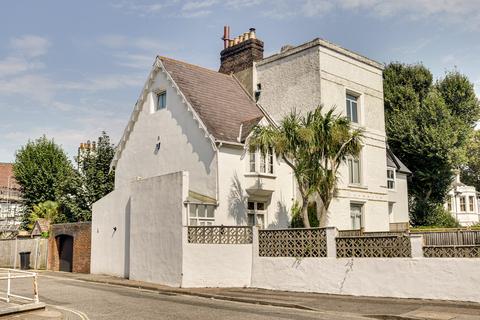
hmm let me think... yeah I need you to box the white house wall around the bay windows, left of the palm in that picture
[215,145,294,228]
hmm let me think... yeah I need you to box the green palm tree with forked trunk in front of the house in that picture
[249,106,363,228]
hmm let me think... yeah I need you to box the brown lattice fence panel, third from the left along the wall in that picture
[335,236,412,258]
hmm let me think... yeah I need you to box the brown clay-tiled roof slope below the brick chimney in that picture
[159,57,263,142]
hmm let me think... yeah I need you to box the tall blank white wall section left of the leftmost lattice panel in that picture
[130,172,188,287]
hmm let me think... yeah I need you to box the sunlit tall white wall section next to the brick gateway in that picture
[90,185,131,277]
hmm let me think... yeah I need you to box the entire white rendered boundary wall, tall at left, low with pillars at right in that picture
[91,178,480,303]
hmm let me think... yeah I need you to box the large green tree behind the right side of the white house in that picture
[384,63,478,225]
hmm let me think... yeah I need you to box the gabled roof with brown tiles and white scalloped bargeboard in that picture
[111,57,268,167]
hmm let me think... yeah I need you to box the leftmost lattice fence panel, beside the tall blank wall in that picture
[188,226,253,244]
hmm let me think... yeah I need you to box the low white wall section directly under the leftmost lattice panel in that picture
[182,228,252,288]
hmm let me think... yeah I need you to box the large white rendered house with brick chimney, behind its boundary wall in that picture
[93,29,409,231]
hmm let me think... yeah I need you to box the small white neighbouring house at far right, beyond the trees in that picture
[444,171,480,227]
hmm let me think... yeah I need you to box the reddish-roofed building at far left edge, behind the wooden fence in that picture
[0,163,23,232]
